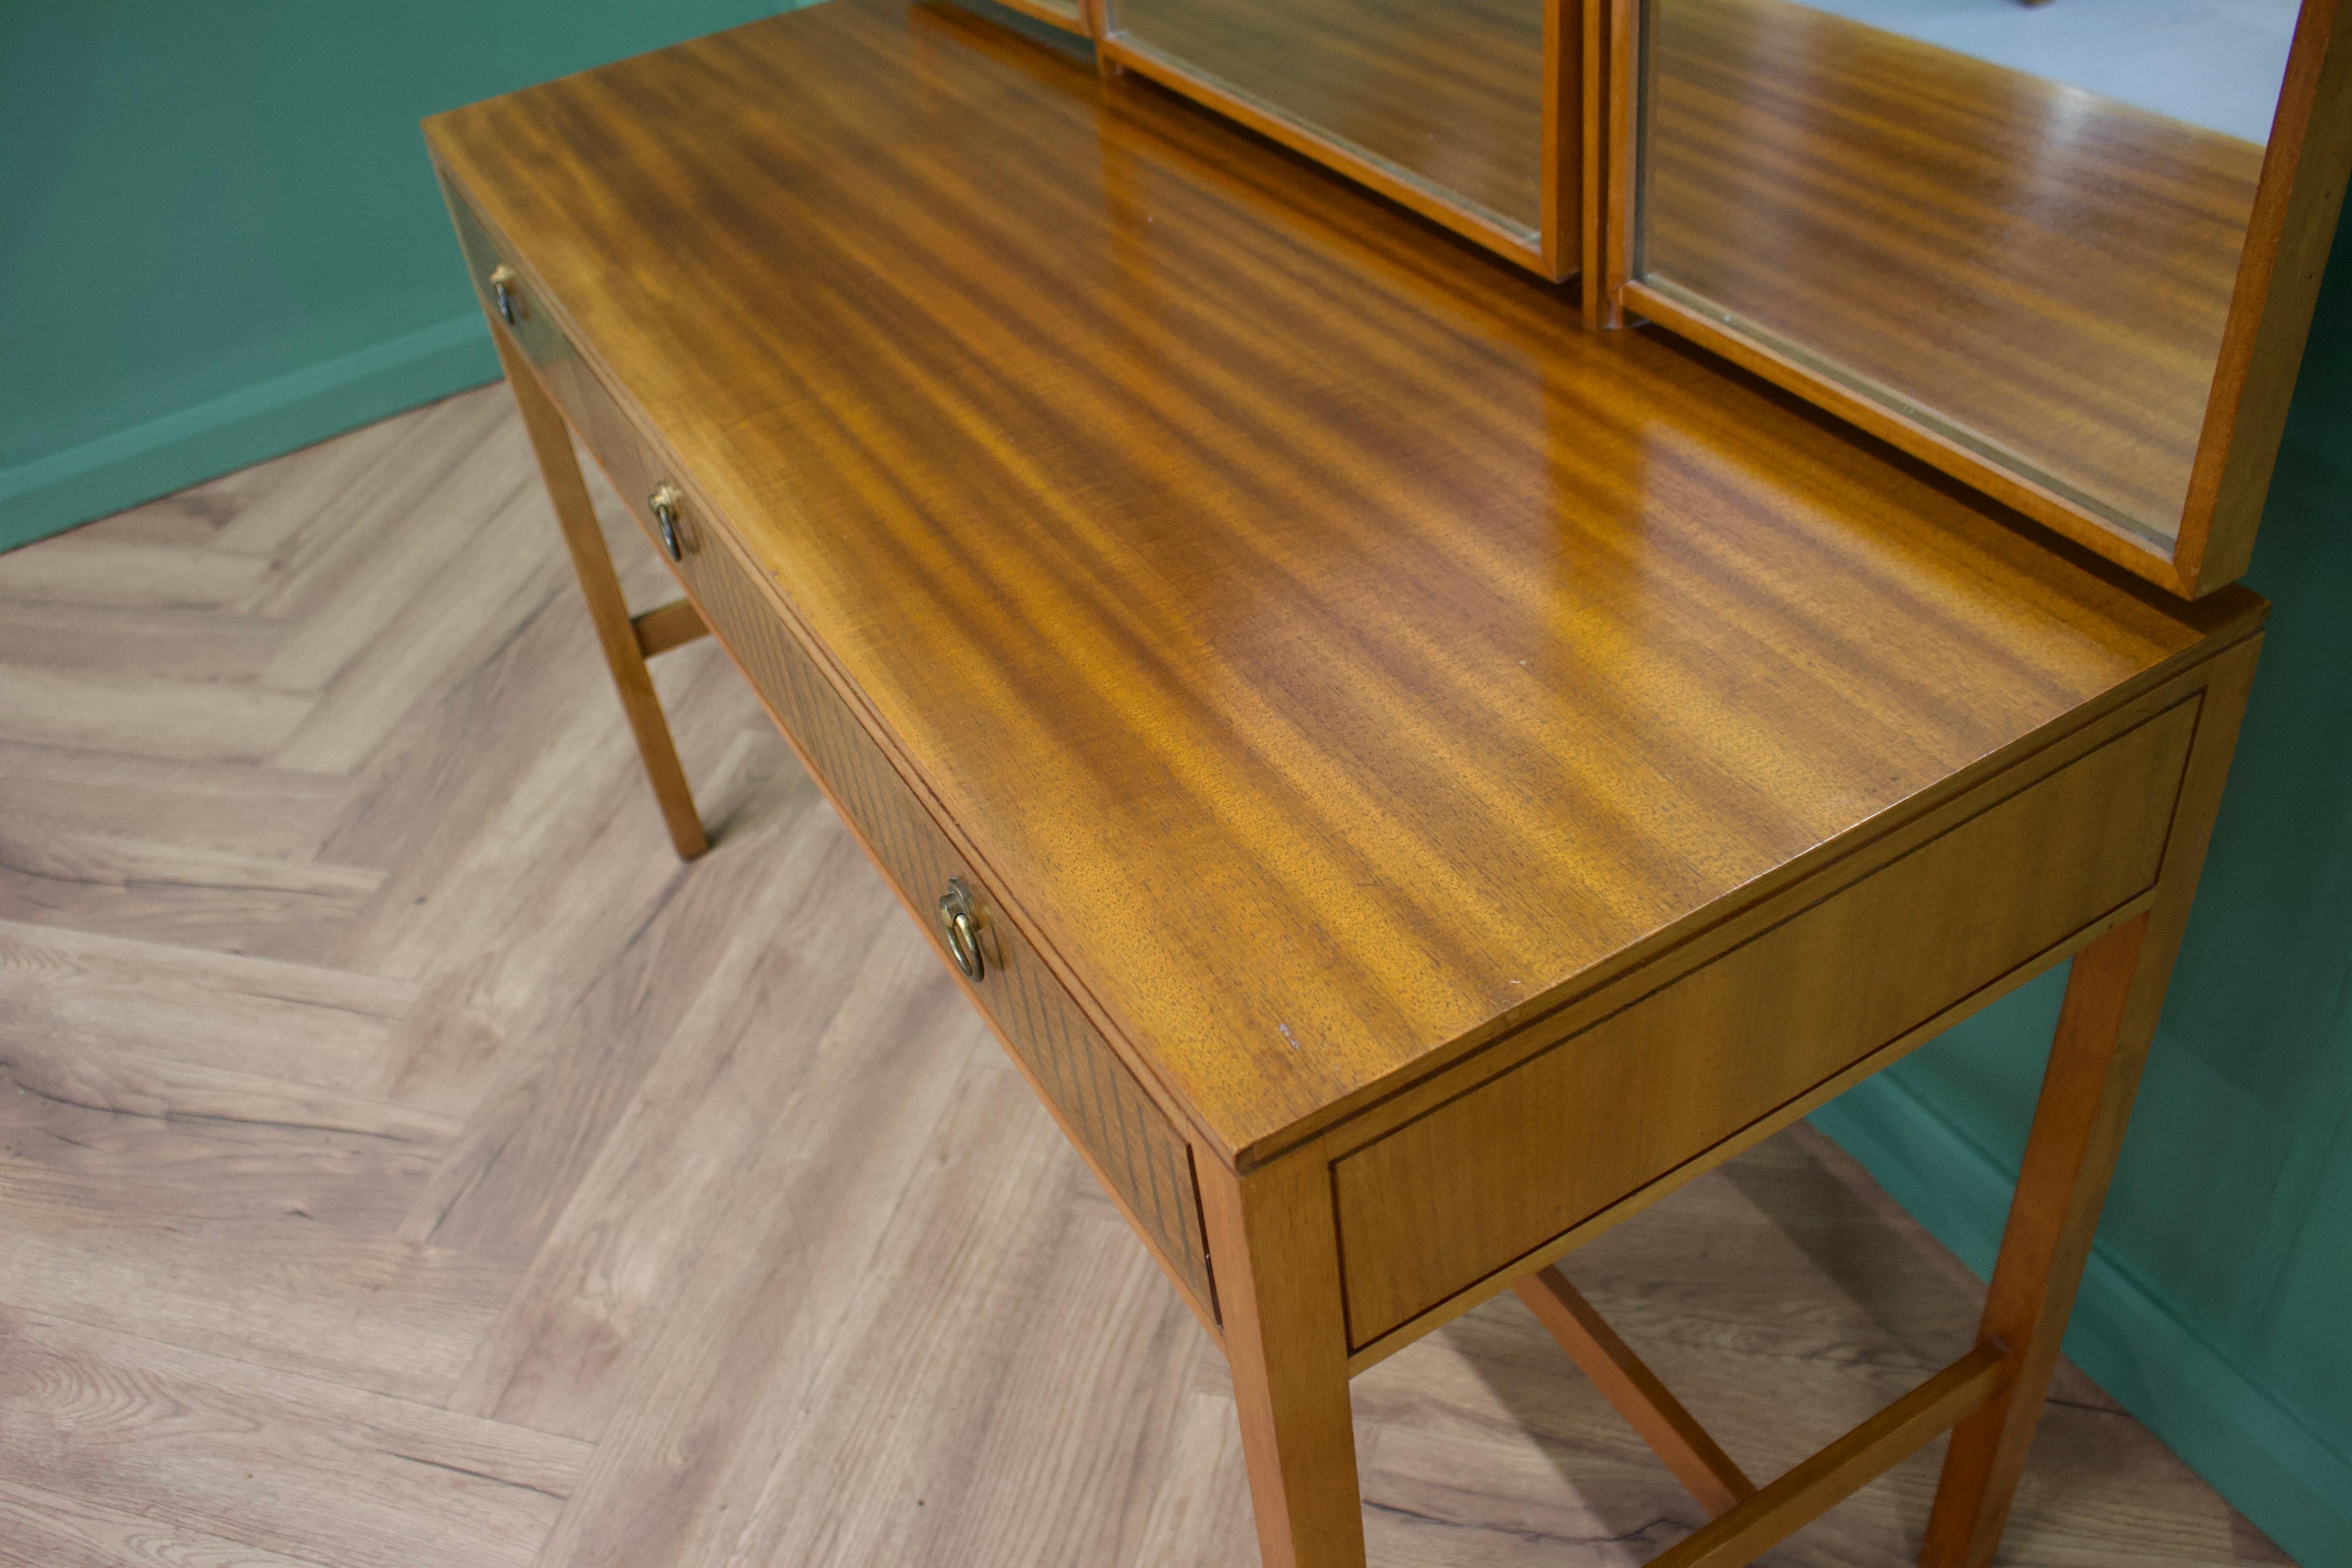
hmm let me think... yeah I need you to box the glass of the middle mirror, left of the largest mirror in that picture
[1108,0,1545,247]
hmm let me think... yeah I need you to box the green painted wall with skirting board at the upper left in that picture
[0,0,795,548]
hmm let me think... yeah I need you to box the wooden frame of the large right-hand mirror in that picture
[1583,0,2352,597]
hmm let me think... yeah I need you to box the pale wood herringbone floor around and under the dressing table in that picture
[0,388,2286,1568]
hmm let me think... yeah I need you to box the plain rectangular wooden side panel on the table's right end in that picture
[1331,698,2197,1349]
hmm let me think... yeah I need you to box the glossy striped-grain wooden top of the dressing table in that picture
[428,0,2260,1161]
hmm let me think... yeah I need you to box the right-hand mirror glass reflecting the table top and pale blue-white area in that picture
[1635,0,2298,541]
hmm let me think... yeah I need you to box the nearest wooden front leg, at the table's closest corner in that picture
[1200,1157,1364,1568]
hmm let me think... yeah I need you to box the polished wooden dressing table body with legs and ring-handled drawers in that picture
[426,0,2343,1568]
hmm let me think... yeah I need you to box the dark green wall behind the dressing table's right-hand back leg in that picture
[1814,190,2352,1568]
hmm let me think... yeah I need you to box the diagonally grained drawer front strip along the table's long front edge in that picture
[449,171,1216,1321]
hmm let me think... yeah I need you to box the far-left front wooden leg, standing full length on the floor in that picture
[489,317,710,861]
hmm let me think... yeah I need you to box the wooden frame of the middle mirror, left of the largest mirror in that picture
[1091,0,1597,282]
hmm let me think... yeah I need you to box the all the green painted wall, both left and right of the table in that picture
[0,0,2352,1568]
